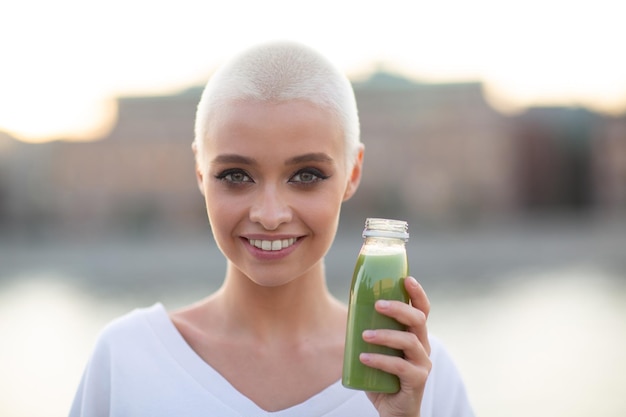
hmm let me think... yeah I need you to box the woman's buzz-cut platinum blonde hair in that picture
[194,42,360,166]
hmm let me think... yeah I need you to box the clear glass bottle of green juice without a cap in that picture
[342,218,409,393]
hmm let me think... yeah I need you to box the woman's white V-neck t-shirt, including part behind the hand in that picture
[70,304,473,417]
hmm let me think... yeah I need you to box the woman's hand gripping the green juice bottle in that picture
[360,277,432,417]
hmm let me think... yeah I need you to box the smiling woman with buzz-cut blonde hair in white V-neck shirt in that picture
[71,43,472,417]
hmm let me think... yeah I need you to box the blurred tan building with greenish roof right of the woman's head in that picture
[355,73,517,221]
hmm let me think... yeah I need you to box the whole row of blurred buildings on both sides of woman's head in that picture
[0,72,626,234]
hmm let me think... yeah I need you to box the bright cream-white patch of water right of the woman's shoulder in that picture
[431,266,626,417]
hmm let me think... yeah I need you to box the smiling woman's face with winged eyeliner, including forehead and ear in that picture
[197,101,362,286]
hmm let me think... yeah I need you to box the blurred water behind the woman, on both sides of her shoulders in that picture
[0,219,626,417]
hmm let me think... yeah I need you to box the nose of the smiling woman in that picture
[250,185,292,230]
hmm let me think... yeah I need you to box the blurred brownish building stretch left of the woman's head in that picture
[0,90,206,234]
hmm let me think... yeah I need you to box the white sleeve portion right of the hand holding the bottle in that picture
[422,336,474,417]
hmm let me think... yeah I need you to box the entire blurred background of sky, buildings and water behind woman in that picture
[0,0,626,417]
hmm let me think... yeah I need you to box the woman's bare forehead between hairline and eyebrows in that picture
[205,101,345,159]
